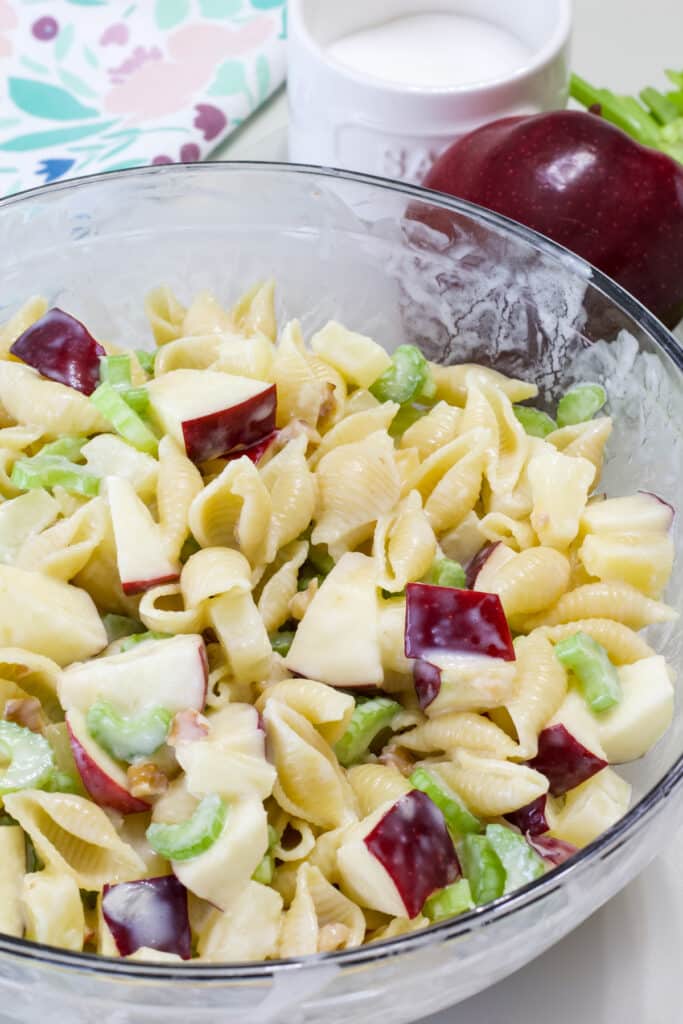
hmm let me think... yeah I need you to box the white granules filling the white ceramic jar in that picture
[328,13,531,88]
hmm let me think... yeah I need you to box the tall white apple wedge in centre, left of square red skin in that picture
[285,552,385,688]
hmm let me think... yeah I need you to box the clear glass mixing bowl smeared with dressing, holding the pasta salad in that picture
[0,164,683,1024]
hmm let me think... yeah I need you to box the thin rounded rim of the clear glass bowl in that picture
[0,161,683,983]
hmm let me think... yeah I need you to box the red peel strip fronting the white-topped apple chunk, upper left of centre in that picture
[182,384,278,462]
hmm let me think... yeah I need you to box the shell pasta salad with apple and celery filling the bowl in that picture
[0,283,676,963]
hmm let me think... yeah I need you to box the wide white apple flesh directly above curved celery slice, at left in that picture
[57,634,208,716]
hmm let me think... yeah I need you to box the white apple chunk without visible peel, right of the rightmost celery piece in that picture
[598,654,674,764]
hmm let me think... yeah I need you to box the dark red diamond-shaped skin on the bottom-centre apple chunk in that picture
[364,790,461,918]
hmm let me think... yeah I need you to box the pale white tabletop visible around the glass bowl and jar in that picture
[216,0,683,1024]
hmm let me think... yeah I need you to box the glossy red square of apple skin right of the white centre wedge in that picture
[404,583,515,662]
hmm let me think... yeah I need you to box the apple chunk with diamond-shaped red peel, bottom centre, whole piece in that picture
[337,790,460,918]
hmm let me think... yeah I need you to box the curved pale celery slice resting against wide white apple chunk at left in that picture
[86,700,173,764]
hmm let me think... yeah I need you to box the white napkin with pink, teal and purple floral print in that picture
[0,0,287,196]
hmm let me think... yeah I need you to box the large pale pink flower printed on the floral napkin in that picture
[103,14,280,124]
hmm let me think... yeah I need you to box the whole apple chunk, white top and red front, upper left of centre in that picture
[147,370,276,462]
